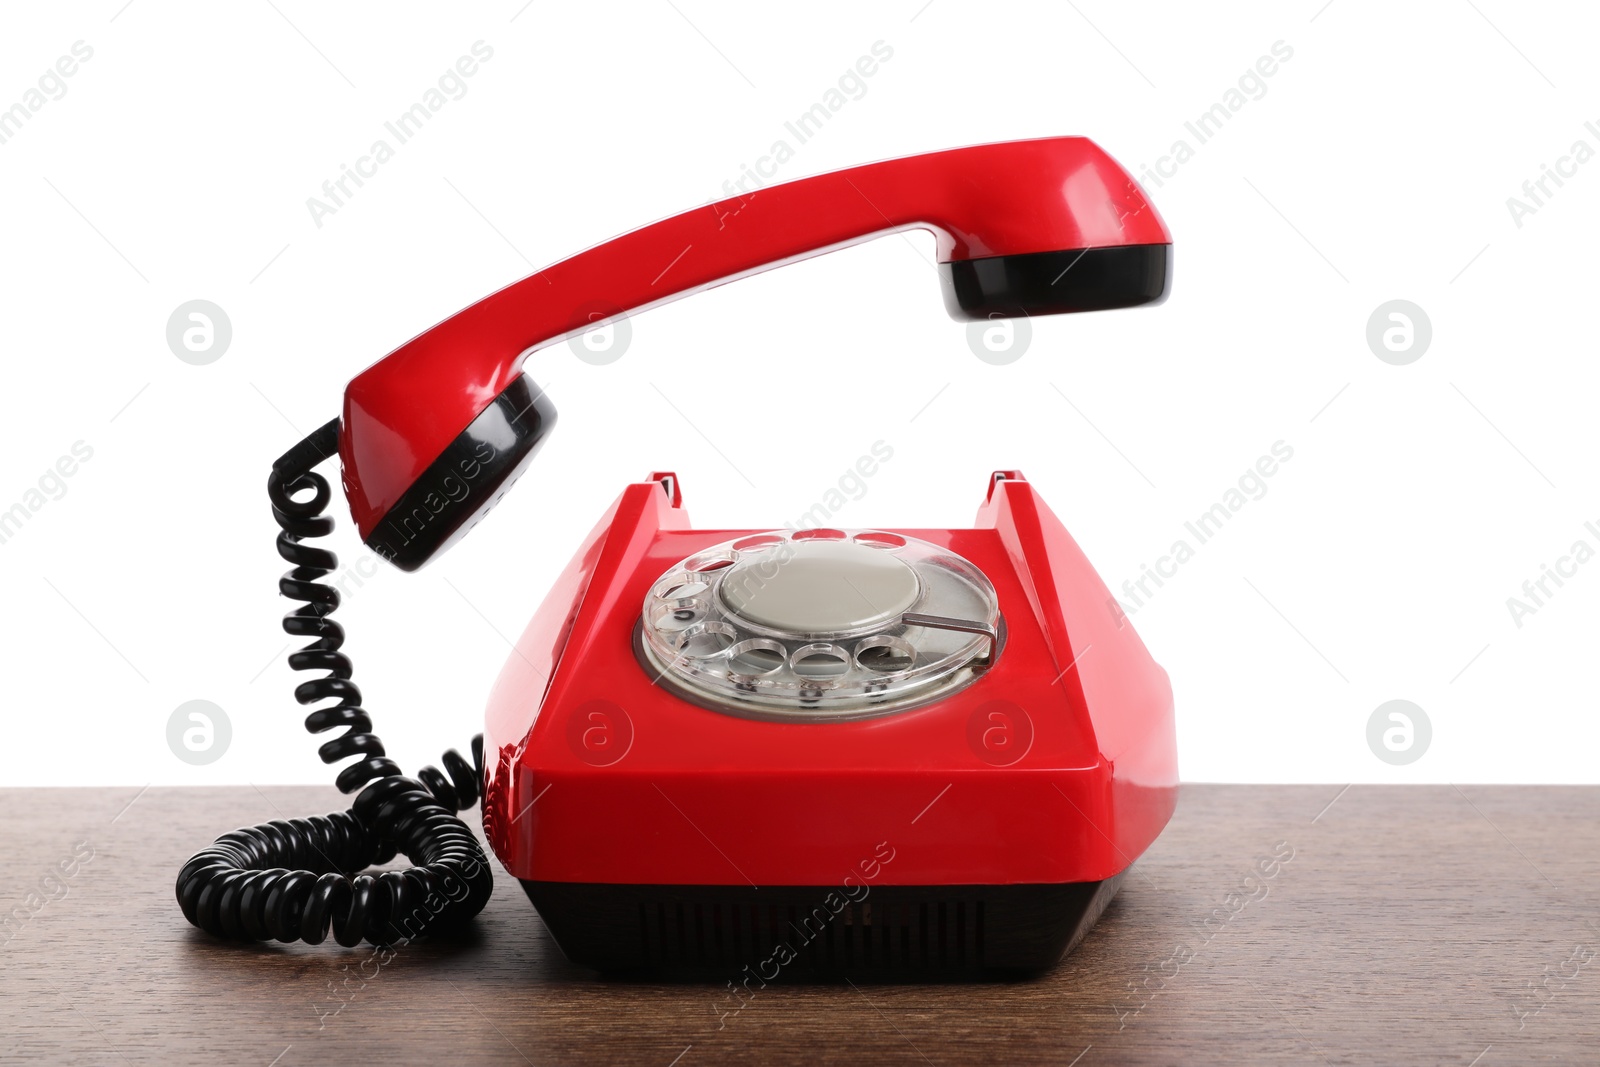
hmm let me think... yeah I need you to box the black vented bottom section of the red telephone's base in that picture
[522,872,1125,984]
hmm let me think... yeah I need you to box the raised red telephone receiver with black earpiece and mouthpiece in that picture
[339,138,1171,571]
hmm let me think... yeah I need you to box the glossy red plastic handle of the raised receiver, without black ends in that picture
[339,138,1171,539]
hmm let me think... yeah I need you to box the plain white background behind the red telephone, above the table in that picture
[0,0,1600,785]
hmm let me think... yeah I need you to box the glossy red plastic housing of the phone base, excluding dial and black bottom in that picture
[483,472,1178,886]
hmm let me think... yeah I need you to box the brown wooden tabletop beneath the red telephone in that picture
[0,785,1600,1067]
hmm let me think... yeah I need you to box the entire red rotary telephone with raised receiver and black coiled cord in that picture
[178,138,1178,976]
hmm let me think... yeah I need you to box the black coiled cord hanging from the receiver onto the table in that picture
[178,419,494,947]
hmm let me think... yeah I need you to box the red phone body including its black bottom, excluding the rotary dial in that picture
[483,470,1178,973]
